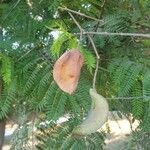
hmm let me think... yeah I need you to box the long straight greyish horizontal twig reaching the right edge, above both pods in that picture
[78,32,150,38]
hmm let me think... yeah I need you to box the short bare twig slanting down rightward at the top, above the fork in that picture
[58,7,103,22]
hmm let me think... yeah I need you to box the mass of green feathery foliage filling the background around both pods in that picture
[0,0,150,150]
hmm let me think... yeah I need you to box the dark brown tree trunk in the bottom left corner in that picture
[0,119,6,150]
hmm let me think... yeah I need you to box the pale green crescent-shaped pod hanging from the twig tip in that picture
[72,89,109,136]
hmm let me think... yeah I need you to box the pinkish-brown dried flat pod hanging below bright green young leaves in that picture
[53,49,84,94]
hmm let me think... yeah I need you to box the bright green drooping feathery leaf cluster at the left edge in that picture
[0,54,16,119]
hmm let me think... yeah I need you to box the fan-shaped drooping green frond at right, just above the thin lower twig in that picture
[109,58,142,96]
